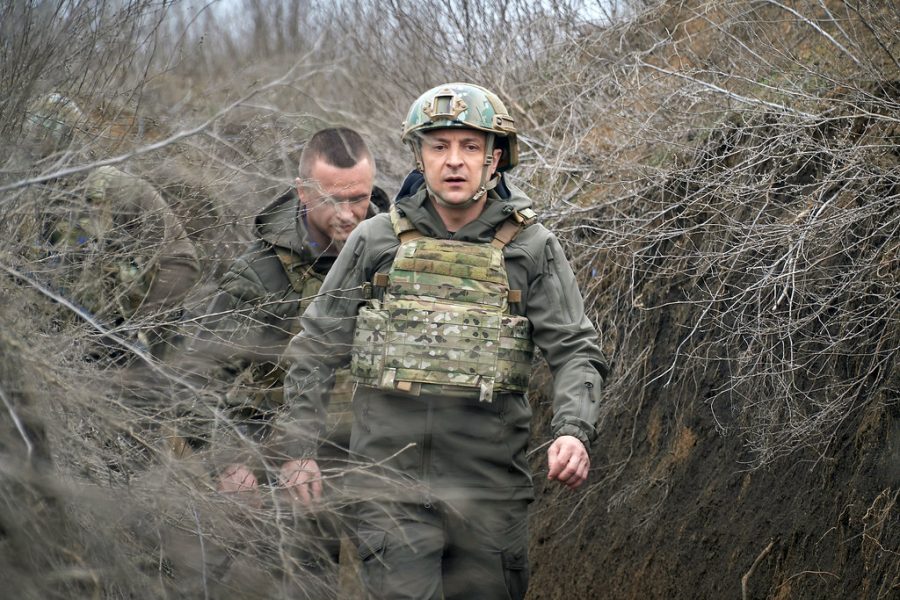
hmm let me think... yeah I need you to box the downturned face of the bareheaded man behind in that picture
[296,159,375,250]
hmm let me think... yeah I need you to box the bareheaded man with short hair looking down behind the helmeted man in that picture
[190,128,388,587]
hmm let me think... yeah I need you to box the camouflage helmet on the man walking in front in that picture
[400,83,519,171]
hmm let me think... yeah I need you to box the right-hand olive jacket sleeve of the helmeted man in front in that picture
[526,230,607,447]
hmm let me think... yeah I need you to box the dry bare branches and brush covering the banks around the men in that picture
[0,0,900,598]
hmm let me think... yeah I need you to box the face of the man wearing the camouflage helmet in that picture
[422,129,501,205]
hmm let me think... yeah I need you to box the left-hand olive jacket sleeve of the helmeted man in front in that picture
[278,221,369,458]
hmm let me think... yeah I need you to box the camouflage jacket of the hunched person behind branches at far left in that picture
[43,167,200,323]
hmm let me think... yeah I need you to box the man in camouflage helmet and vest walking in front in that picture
[281,83,606,600]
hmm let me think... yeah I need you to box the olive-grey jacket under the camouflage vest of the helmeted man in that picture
[282,173,606,500]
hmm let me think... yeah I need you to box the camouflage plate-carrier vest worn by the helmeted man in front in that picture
[350,208,535,402]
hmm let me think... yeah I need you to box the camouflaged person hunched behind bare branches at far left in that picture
[23,93,200,360]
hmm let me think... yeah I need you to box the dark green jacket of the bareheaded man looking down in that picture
[190,188,384,438]
